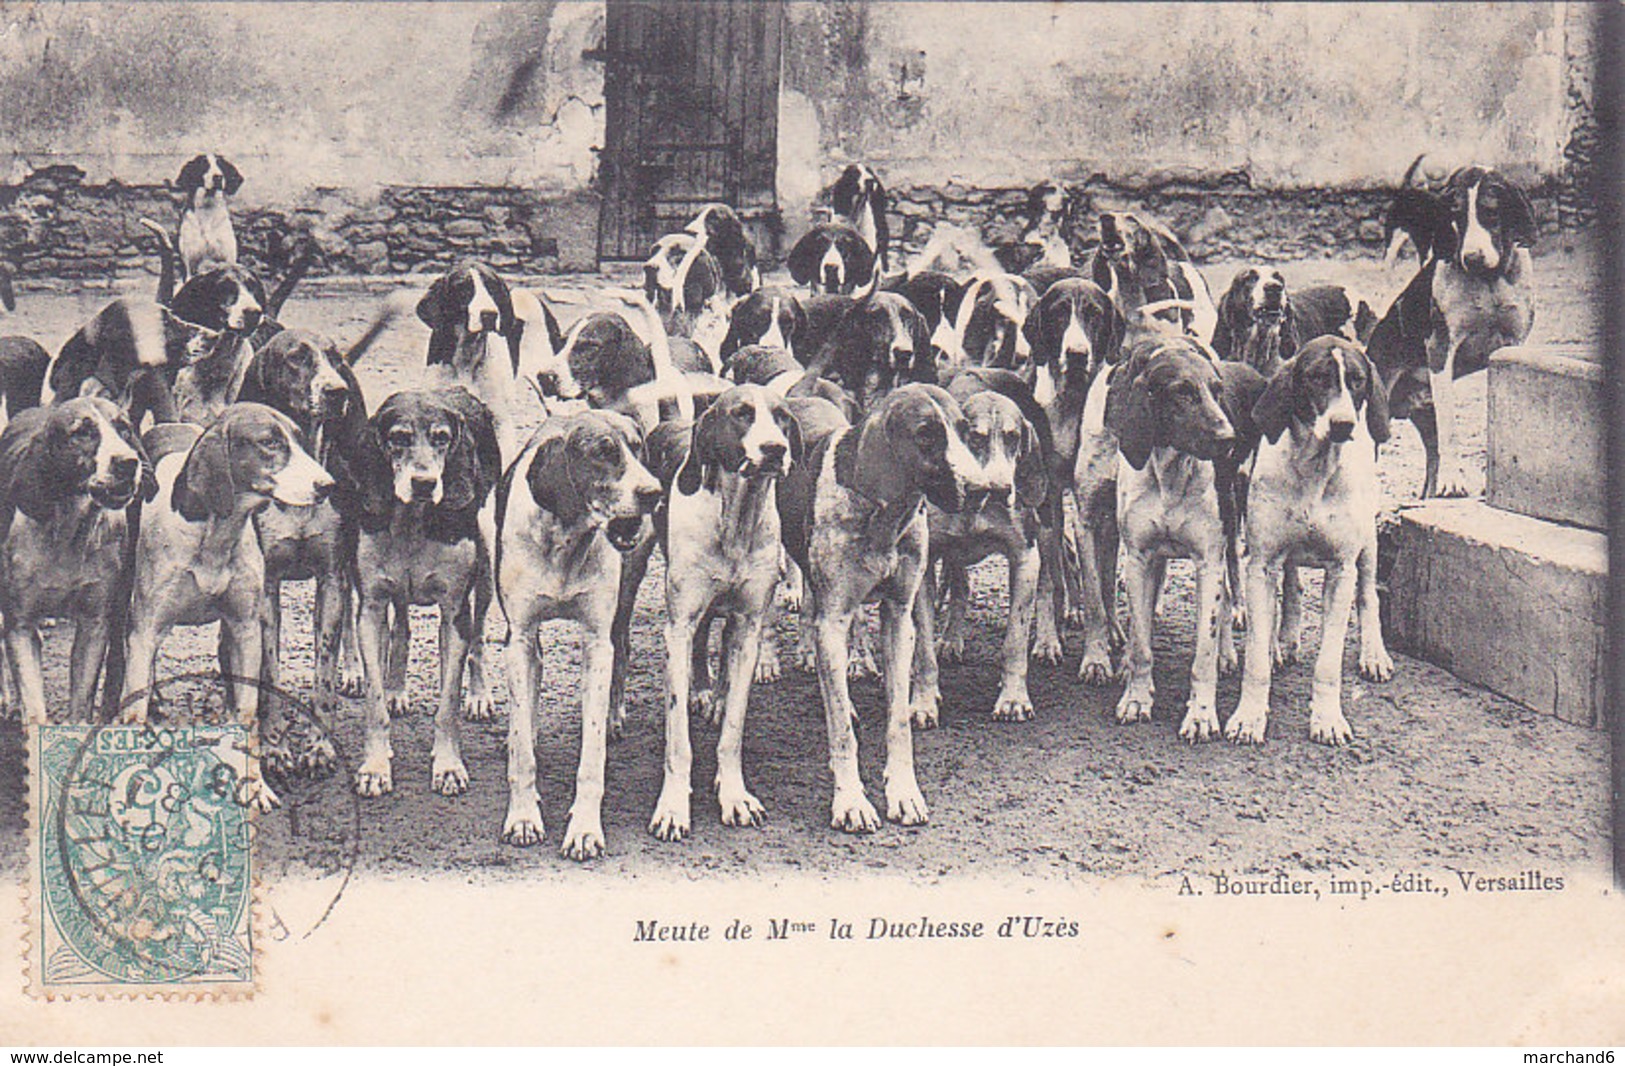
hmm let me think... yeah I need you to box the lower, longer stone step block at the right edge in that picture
[1383,499,1607,728]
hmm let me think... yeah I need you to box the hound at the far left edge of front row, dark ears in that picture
[0,397,158,723]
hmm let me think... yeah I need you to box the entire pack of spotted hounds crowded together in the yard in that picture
[0,154,1536,860]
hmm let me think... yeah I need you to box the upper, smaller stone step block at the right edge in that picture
[1484,345,1607,530]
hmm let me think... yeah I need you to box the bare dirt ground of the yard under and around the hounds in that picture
[0,242,1609,882]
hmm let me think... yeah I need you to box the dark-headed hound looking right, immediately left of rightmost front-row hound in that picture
[1105,336,1264,743]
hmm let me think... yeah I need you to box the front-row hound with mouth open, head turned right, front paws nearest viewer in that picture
[497,410,660,861]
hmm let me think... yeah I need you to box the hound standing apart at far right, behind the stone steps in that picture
[1367,166,1539,497]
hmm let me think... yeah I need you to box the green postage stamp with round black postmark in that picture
[29,725,255,998]
